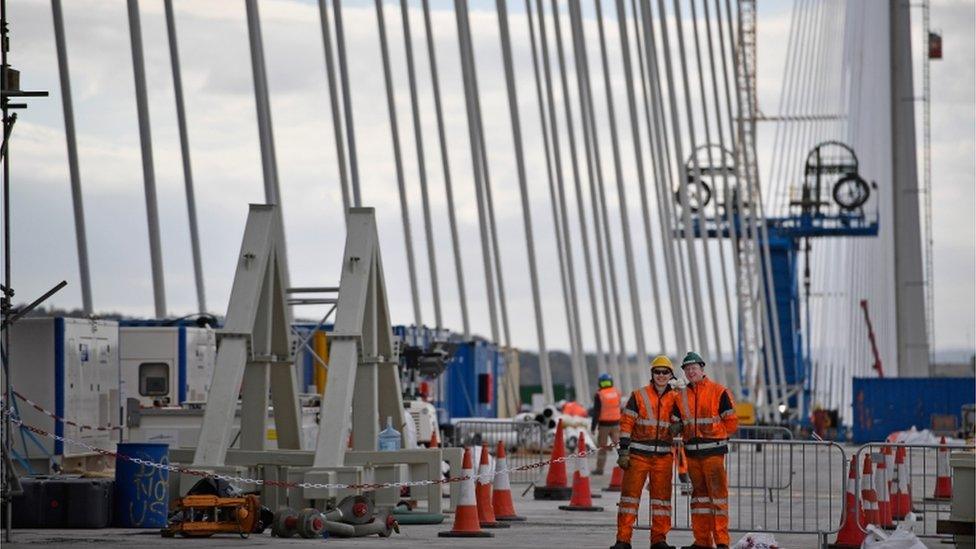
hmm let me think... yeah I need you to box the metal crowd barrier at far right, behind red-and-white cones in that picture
[845,442,974,541]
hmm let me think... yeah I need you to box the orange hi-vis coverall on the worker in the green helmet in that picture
[678,377,739,547]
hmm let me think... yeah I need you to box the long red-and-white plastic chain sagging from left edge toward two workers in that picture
[6,404,617,490]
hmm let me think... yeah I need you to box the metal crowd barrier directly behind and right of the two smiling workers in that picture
[672,439,847,546]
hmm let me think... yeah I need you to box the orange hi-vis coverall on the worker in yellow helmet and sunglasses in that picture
[617,385,677,545]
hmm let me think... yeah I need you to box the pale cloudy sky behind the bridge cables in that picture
[1,0,976,356]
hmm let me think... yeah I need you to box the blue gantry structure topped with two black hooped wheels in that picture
[675,141,879,421]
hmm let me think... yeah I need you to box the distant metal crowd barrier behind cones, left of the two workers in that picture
[446,419,548,484]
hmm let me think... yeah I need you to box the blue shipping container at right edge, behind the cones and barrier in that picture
[853,377,976,444]
